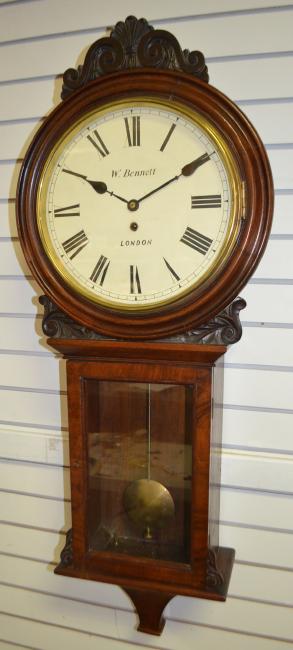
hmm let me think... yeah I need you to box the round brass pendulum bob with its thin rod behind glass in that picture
[123,384,175,540]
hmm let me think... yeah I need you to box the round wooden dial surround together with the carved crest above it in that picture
[17,17,272,340]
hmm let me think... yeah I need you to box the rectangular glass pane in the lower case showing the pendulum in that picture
[85,379,194,563]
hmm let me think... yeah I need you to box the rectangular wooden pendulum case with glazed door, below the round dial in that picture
[50,340,234,634]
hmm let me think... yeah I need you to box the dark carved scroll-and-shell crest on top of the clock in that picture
[61,16,209,99]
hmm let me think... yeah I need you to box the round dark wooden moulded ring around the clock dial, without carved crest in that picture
[16,68,273,340]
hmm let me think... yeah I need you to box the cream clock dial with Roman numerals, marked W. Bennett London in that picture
[38,100,237,310]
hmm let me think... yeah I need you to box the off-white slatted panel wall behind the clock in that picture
[0,0,293,650]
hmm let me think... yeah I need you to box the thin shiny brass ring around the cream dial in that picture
[36,94,244,313]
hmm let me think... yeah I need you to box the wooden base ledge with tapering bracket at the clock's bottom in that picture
[55,547,235,636]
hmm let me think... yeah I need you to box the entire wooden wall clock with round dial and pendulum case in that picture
[17,16,272,634]
